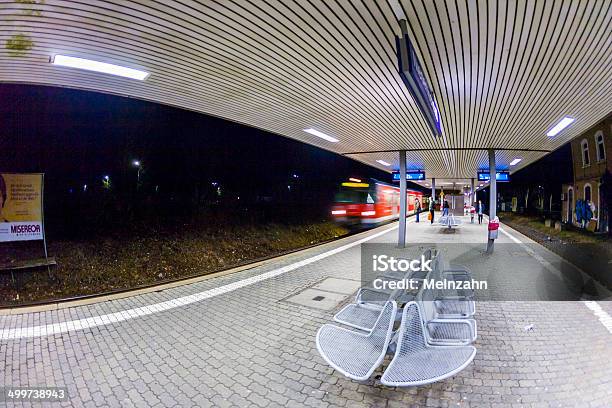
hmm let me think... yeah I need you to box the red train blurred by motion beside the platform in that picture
[331,178,427,226]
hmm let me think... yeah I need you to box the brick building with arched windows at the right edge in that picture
[562,114,612,231]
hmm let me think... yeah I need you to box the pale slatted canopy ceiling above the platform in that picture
[0,0,612,178]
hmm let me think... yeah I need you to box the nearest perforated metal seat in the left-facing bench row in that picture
[317,301,397,381]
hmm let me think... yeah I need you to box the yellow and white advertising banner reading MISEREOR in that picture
[0,173,44,242]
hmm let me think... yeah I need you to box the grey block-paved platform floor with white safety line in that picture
[0,215,612,407]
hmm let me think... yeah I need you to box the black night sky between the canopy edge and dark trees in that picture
[0,85,390,206]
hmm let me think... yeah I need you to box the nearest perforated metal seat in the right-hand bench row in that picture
[380,302,476,387]
